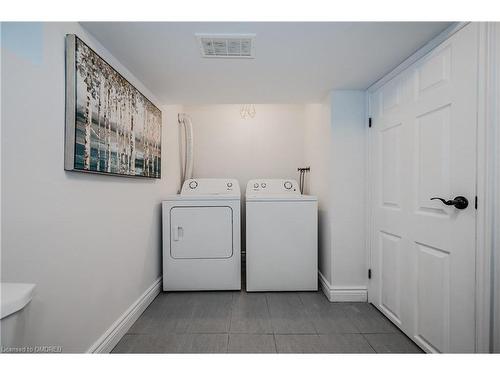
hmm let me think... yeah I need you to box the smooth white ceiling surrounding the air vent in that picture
[82,22,450,104]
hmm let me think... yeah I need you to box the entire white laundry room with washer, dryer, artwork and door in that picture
[0,1,500,370]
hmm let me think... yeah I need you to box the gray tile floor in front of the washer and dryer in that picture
[113,291,421,353]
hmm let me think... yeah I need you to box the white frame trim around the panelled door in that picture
[365,22,500,353]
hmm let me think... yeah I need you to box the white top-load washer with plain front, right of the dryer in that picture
[246,179,318,291]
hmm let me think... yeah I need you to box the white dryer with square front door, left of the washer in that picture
[162,178,241,291]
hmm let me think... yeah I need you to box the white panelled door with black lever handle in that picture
[369,24,478,352]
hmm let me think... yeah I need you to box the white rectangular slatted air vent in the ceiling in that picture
[196,34,255,59]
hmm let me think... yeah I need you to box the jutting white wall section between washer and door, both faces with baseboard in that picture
[305,91,367,301]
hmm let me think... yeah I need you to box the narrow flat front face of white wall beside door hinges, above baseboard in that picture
[331,91,367,289]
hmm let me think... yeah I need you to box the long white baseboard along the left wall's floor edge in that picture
[87,277,162,353]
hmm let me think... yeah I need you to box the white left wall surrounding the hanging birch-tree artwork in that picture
[1,23,181,352]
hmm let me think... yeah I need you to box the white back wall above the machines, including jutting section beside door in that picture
[184,99,367,299]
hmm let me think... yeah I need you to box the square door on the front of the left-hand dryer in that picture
[170,206,233,259]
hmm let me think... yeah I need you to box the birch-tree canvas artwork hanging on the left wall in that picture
[64,34,162,178]
